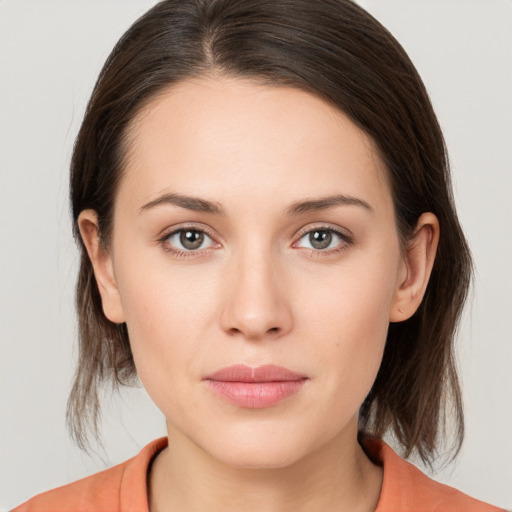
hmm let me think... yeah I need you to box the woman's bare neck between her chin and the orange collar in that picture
[149,422,382,512]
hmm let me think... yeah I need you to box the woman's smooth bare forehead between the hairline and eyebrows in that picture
[121,77,389,212]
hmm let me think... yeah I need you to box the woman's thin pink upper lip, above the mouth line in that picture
[206,364,306,382]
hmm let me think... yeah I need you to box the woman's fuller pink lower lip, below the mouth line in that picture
[207,379,307,409]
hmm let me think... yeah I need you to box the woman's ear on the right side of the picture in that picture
[389,213,439,322]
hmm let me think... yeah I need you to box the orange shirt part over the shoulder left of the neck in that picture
[12,438,167,512]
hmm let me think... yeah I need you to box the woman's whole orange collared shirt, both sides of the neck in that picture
[12,437,502,512]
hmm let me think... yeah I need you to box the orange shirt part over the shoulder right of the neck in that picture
[364,439,503,512]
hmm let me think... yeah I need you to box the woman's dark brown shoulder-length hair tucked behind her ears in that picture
[67,0,471,462]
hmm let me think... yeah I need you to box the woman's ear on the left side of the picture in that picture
[78,210,125,324]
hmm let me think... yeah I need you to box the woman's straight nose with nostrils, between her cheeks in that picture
[220,244,293,340]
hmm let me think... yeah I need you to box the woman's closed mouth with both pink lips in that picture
[204,365,309,409]
